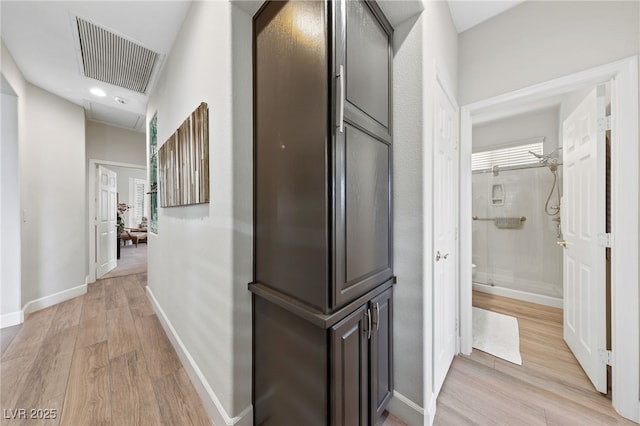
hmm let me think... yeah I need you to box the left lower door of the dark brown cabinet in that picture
[331,305,371,426]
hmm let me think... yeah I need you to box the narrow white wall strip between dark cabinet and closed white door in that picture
[392,13,425,414]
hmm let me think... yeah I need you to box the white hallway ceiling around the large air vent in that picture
[0,0,191,131]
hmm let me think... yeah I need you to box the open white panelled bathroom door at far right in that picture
[562,85,607,393]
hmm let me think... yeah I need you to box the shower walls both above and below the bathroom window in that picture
[472,107,562,307]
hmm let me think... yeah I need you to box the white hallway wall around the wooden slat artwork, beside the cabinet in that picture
[147,2,252,424]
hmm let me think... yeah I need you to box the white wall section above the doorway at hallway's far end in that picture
[86,120,147,167]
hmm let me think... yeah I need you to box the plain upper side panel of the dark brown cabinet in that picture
[254,1,330,312]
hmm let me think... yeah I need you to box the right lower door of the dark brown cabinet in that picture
[369,288,393,424]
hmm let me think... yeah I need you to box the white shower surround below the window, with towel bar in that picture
[473,167,562,305]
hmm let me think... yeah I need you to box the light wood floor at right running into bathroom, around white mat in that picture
[434,292,635,426]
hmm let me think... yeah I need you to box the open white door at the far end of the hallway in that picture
[96,166,118,278]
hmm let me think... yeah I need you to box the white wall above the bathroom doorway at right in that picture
[458,1,640,105]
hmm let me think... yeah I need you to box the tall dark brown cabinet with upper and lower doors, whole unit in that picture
[249,0,393,426]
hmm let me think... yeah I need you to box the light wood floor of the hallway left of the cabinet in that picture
[0,274,211,426]
